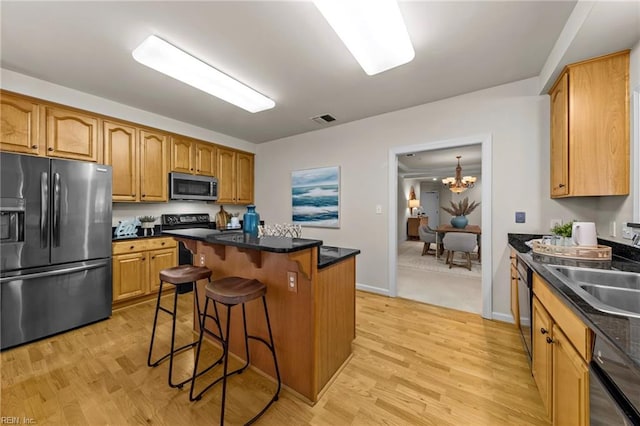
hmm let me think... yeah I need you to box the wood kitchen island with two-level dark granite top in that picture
[163,229,360,404]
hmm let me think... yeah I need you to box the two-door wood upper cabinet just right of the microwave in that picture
[218,147,254,204]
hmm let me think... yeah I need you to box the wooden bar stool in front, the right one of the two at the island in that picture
[189,277,282,425]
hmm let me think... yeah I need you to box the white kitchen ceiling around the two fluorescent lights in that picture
[0,1,575,143]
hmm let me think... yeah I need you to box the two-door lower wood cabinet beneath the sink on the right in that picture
[531,274,593,426]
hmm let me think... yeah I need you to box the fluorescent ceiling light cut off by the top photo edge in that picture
[314,0,415,75]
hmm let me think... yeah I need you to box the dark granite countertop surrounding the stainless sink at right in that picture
[508,234,640,374]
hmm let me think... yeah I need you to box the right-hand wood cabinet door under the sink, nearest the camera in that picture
[552,325,589,426]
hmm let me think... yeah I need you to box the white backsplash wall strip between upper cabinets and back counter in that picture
[111,201,246,226]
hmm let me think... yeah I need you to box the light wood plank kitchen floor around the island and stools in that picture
[0,292,548,426]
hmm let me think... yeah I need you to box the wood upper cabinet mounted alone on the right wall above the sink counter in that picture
[549,50,630,198]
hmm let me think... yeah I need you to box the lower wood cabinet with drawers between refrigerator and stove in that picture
[112,238,178,306]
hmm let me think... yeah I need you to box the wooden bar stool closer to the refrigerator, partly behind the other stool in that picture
[147,265,211,388]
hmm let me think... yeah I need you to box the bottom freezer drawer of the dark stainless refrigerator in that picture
[0,258,112,349]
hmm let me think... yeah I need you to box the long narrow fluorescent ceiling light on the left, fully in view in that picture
[132,35,276,112]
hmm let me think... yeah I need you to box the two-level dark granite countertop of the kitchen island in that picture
[162,228,360,269]
